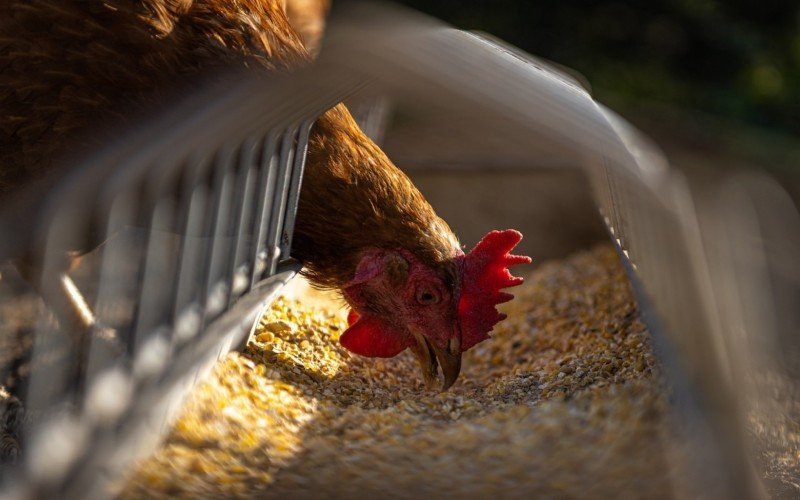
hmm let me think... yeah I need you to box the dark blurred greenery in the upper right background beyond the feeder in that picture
[400,0,800,168]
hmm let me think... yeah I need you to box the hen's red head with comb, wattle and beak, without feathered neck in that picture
[340,229,531,389]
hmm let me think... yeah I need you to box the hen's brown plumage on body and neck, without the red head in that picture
[0,0,459,288]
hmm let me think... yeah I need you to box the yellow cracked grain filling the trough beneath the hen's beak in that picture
[122,246,688,498]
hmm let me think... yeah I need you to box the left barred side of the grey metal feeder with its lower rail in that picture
[0,68,318,498]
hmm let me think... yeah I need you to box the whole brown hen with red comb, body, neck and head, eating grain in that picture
[0,0,530,389]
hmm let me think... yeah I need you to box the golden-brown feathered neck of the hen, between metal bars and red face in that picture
[293,105,459,288]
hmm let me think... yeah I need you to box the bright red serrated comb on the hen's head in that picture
[456,229,531,351]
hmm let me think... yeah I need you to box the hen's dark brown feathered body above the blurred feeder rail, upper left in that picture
[0,0,308,195]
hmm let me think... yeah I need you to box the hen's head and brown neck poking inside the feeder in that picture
[292,106,530,388]
